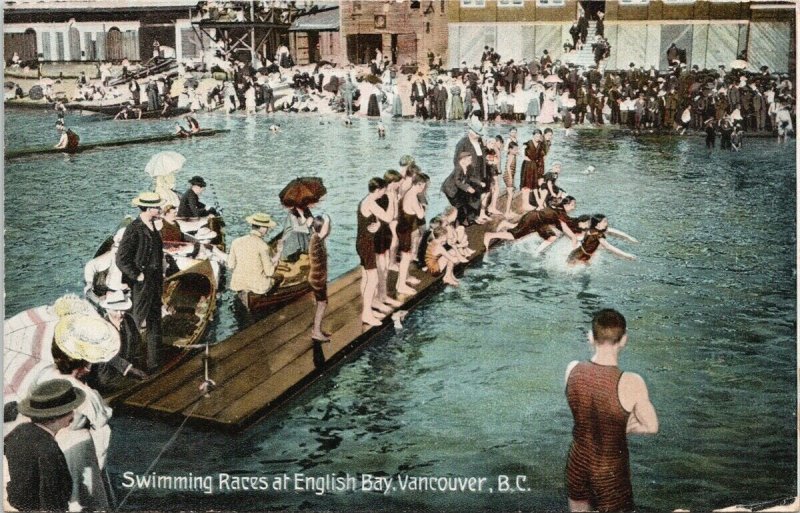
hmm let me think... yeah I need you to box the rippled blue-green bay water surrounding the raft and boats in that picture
[5,107,797,511]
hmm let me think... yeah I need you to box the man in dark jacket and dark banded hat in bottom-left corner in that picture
[4,379,86,511]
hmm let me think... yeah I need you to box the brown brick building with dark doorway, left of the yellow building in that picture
[339,0,448,66]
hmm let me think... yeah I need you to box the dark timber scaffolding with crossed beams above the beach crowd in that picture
[192,0,318,62]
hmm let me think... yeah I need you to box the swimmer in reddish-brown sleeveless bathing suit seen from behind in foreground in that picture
[565,309,658,512]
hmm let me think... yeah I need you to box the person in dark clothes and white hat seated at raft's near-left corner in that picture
[86,290,147,393]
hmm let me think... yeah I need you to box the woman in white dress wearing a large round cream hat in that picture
[34,314,120,510]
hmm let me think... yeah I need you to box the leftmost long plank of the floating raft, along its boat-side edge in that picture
[124,271,361,411]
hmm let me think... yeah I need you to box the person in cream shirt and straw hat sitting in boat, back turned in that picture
[228,212,283,304]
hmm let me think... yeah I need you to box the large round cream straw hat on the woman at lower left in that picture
[55,314,120,363]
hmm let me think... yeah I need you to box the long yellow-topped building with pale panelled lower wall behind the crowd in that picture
[447,0,796,73]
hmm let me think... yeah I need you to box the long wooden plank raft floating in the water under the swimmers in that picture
[115,218,494,432]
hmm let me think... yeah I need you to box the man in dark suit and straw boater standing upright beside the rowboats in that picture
[117,192,164,374]
